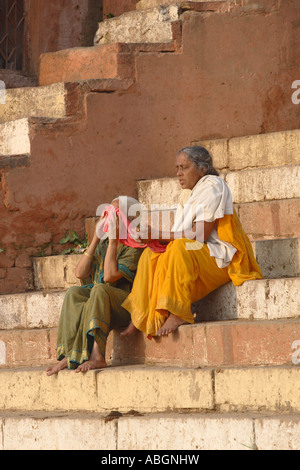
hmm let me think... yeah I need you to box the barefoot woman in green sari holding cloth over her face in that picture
[46,198,143,376]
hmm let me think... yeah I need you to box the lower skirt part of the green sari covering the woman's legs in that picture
[57,284,130,369]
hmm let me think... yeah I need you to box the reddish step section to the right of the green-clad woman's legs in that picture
[106,318,300,367]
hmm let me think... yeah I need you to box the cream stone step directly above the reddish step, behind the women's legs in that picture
[0,277,300,330]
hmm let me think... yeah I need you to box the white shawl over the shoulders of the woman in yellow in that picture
[172,175,237,268]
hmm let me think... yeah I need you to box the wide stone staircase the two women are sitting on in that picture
[0,122,300,450]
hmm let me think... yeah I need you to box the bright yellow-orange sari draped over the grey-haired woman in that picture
[122,211,263,336]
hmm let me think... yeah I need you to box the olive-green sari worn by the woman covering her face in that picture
[57,240,143,369]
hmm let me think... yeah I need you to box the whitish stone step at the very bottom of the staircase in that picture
[0,412,300,452]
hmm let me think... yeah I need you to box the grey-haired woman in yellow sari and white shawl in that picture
[122,147,262,337]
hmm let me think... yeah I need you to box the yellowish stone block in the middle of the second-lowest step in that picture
[97,366,214,413]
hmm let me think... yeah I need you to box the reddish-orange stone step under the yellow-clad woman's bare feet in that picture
[0,318,300,369]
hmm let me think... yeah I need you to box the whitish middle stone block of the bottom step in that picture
[118,413,254,450]
